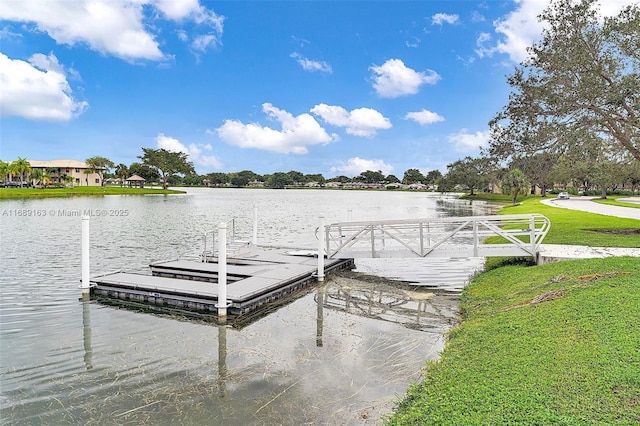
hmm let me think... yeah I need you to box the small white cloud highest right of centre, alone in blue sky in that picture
[369,59,440,98]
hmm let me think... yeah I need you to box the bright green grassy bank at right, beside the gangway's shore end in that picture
[387,197,640,425]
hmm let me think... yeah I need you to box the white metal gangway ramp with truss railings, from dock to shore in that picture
[324,214,551,260]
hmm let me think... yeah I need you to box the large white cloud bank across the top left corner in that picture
[0,0,224,62]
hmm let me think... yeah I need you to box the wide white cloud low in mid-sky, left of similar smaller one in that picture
[216,103,338,154]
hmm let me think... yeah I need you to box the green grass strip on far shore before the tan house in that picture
[0,186,184,199]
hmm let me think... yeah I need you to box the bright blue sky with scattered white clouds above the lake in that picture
[0,0,632,178]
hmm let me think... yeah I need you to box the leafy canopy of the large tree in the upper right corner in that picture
[489,0,640,160]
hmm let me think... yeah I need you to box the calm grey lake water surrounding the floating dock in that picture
[0,189,498,425]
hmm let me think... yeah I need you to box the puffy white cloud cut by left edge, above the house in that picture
[0,53,89,121]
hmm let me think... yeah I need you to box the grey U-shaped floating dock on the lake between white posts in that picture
[90,248,355,314]
